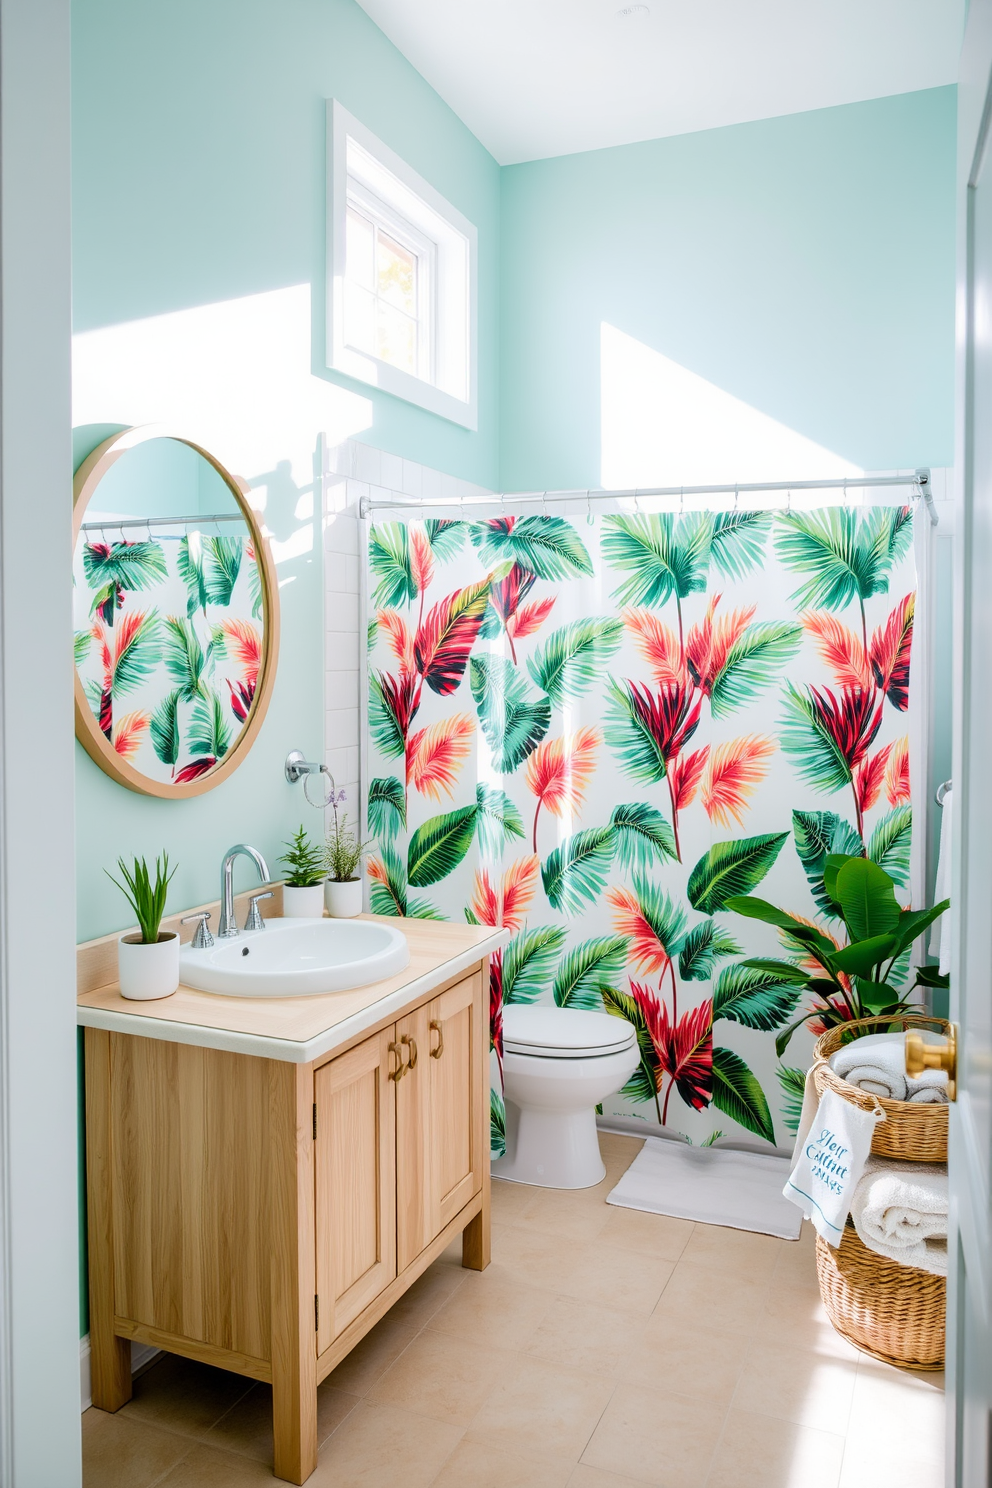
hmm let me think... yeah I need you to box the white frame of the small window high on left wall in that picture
[327,98,479,430]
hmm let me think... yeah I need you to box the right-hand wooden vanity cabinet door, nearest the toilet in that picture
[396,973,488,1271]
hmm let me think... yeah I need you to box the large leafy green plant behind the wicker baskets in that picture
[726,853,950,1058]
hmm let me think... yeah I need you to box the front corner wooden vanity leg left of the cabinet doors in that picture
[269,1059,317,1484]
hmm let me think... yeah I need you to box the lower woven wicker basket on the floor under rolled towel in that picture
[817,1225,947,1369]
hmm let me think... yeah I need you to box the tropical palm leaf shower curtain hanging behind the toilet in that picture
[367,506,915,1153]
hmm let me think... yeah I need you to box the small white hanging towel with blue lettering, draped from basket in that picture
[782,1091,885,1245]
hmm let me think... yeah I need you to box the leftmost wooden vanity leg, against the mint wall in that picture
[85,1028,131,1411]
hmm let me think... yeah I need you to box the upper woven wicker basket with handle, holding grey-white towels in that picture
[814,1013,950,1166]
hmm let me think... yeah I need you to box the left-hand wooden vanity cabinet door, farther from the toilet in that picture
[314,1028,396,1353]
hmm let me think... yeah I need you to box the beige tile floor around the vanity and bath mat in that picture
[83,1134,943,1488]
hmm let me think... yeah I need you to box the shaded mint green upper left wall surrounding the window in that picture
[73,0,500,484]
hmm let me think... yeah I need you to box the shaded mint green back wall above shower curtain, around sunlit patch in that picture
[500,88,956,491]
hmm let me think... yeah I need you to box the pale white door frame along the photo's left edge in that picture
[0,0,82,1488]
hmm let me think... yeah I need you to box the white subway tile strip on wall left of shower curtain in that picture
[323,439,491,886]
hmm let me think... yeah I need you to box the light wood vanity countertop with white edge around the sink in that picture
[76,890,509,1064]
